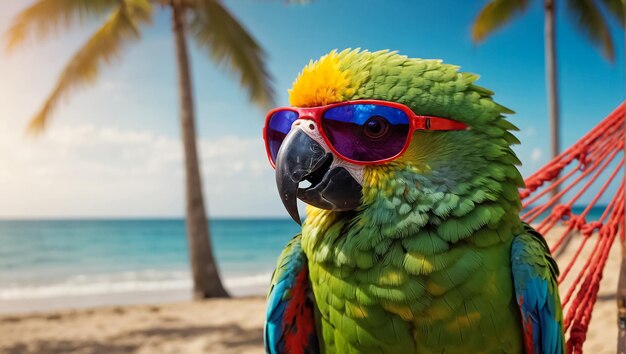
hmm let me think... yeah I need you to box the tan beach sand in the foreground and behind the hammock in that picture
[0,225,620,354]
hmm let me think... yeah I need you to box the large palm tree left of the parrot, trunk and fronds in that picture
[6,0,273,299]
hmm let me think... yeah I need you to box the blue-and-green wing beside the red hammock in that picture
[511,225,565,354]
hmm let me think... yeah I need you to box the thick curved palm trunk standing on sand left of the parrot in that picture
[172,1,228,299]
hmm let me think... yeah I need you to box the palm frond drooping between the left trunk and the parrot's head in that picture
[189,0,274,107]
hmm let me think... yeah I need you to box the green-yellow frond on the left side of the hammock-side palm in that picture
[472,0,530,42]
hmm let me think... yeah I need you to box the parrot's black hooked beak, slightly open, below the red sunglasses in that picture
[276,128,362,224]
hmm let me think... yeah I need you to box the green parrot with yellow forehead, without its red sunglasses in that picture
[264,49,565,354]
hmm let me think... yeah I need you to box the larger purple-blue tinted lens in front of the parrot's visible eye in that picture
[322,104,410,162]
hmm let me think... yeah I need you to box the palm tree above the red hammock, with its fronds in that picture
[472,0,624,169]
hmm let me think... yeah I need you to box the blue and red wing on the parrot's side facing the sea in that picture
[264,235,319,354]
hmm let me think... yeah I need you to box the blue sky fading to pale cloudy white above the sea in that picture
[0,0,624,218]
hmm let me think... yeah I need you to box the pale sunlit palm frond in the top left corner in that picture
[5,0,122,51]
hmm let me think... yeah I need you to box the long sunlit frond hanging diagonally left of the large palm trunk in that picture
[28,0,152,133]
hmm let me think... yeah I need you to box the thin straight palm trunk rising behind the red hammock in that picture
[544,0,560,201]
